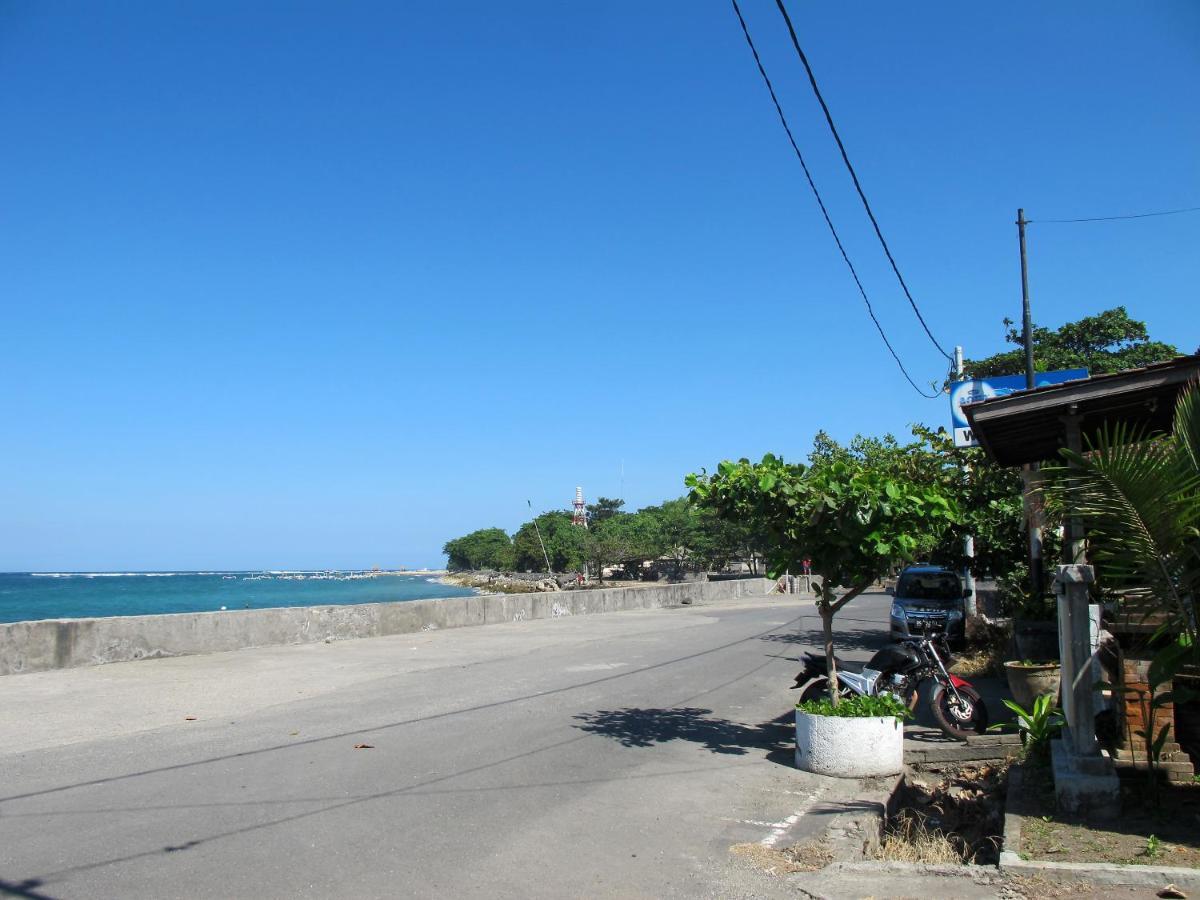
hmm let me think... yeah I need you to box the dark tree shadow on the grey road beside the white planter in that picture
[575,707,796,764]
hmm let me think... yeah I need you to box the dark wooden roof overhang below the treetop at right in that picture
[962,356,1200,466]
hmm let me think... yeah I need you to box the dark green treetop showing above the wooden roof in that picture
[962,306,1180,378]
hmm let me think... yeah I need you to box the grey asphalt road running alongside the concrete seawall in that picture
[0,595,889,899]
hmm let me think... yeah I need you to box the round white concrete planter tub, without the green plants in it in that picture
[796,709,904,778]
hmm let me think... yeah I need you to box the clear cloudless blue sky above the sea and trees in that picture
[0,0,1200,570]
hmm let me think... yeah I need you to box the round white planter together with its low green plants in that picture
[796,694,912,778]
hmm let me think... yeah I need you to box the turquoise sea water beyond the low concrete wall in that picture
[0,571,474,622]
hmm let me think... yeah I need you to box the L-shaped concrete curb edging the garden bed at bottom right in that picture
[998,766,1200,890]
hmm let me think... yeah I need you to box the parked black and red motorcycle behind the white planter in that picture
[793,635,988,740]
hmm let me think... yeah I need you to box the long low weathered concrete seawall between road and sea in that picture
[0,578,772,676]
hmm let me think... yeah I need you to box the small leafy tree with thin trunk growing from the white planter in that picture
[685,454,959,704]
